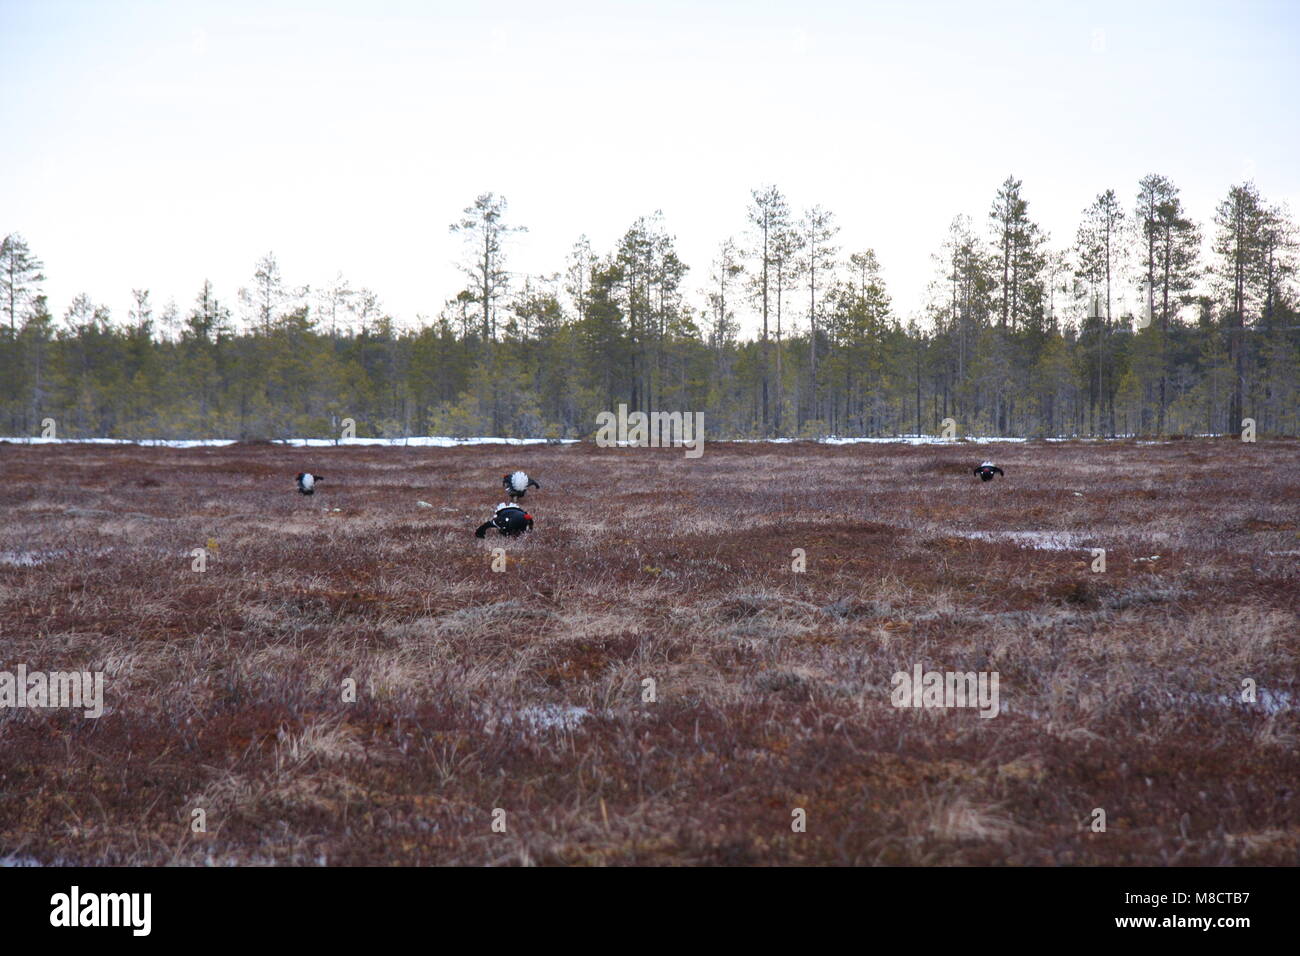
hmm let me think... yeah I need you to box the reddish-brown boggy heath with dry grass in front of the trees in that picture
[0,440,1300,865]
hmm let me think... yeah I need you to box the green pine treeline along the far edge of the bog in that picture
[0,176,1300,438]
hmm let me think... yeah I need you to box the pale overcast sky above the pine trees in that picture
[0,0,1300,328]
